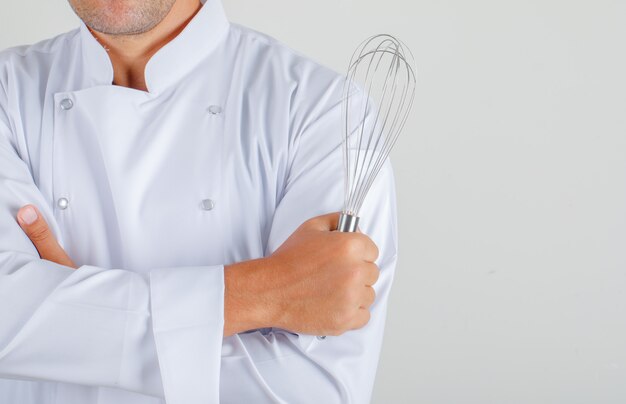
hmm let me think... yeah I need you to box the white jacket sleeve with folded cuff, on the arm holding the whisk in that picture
[0,94,224,404]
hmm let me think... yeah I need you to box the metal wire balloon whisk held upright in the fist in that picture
[337,34,416,232]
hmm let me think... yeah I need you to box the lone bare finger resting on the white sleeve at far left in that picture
[17,205,76,268]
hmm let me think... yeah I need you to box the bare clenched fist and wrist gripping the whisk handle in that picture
[225,213,379,335]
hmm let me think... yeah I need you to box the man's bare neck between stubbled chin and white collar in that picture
[90,0,202,91]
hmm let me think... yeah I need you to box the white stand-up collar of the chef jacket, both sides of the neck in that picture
[80,0,230,93]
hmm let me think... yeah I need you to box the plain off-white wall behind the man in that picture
[0,0,626,404]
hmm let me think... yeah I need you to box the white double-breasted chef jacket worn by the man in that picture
[0,0,397,404]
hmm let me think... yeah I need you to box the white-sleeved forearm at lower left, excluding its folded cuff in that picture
[0,251,163,396]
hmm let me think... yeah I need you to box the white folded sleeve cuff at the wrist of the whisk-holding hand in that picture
[150,265,224,404]
